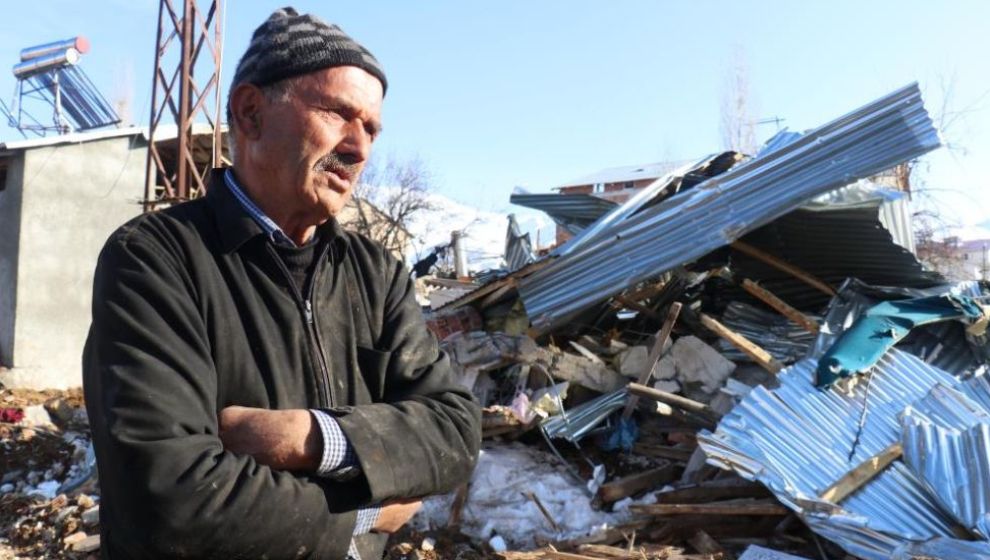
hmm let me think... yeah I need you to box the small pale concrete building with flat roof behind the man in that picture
[0,127,224,388]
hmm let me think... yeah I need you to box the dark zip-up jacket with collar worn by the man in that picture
[83,173,480,560]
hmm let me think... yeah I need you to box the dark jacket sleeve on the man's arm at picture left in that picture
[83,232,355,559]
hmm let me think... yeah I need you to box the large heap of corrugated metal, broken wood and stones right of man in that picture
[406,85,990,560]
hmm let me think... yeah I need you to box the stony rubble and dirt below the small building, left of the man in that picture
[0,389,100,558]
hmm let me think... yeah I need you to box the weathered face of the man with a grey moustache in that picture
[252,66,383,223]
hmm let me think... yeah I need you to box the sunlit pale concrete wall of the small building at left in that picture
[0,137,146,388]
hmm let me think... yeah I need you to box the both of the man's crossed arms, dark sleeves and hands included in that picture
[83,232,480,560]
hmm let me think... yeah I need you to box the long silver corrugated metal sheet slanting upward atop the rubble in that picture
[519,84,940,329]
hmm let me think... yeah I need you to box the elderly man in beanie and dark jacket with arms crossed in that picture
[83,8,480,560]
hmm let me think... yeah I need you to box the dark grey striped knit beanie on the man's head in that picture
[230,7,388,93]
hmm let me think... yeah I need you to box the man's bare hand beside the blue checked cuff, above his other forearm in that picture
[219,406,322,470]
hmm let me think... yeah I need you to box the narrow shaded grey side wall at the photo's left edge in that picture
[0,153,24,367]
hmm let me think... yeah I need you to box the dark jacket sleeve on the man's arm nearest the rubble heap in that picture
[333,252,481,503]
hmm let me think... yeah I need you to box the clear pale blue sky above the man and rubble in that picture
[0,0,990,238]
